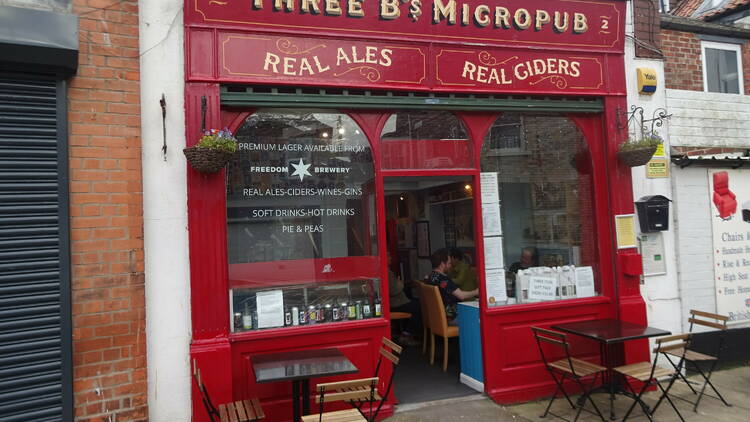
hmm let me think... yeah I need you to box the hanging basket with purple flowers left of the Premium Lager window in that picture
[182,128,237,173]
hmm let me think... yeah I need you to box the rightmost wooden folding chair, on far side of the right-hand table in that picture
[662,309,732,412]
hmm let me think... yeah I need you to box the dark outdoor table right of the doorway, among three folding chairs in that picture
[552,319,672,420]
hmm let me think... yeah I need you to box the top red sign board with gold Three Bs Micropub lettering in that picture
[191,0,625,53]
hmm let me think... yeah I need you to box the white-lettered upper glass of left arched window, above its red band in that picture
[227,110,377,264]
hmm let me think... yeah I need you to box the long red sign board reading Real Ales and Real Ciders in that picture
[218,32,606,93]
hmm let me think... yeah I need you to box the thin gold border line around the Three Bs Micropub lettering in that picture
[193,0,624,48]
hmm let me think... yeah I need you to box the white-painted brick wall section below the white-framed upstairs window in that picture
[667,89,750,148]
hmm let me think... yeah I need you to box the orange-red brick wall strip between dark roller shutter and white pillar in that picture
[69,0,148,422]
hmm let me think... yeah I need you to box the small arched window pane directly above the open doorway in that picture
[380,110,474,170]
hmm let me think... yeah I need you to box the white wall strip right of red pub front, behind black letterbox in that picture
[625,2,683,332]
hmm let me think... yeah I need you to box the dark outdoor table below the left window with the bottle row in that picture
[251,348,358,422]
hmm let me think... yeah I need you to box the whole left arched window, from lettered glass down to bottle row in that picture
[226,109,380,331]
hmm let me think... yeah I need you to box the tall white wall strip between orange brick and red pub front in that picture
[138,0,192,422]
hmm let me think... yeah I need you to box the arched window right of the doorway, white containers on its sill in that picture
[481,113,601,306]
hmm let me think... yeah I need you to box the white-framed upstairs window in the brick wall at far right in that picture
[701,41,743,94]
